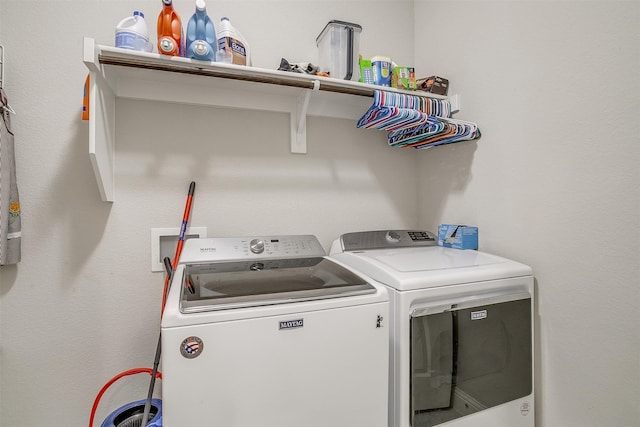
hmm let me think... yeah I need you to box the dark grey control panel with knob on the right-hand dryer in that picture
[340,230,438,252]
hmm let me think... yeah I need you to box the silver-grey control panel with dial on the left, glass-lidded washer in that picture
[180,235,326,263]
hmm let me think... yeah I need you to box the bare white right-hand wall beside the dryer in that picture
[415,1,640,427]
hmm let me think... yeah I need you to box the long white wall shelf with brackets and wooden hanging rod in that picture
[83,38,458,202]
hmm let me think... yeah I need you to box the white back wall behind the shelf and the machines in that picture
[0,0,418,427]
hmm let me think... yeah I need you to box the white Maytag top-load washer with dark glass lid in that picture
[161,235,389,427]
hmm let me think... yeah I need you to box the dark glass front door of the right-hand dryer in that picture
[410,292,533,427]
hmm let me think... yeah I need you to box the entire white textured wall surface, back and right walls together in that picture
[0,0,640,427]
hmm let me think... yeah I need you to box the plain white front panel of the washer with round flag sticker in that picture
[162,303,389,427]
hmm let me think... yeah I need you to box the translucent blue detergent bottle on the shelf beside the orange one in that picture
[186,0,217,61]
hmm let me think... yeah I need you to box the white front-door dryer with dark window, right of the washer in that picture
[330,230,534,427]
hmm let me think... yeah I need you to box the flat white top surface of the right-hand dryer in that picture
[332,246,532,290]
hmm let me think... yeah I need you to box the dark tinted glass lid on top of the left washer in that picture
[180,257,376,313]
